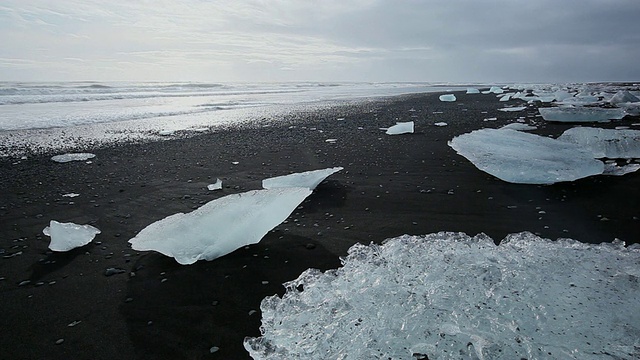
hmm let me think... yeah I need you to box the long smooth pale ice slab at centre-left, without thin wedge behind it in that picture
[129,188,311,265]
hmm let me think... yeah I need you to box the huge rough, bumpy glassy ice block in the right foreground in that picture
[244,232,640,360]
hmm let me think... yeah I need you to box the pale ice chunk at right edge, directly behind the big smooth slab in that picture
[558,127,640,159]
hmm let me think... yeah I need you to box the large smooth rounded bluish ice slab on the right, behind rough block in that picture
[449,129,604,184]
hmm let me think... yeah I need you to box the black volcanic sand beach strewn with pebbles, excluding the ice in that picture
[0,93,640,359]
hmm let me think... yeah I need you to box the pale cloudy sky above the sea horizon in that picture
[0,0,640,83]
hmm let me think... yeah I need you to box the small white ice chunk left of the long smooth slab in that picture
[42,220,100,251]
